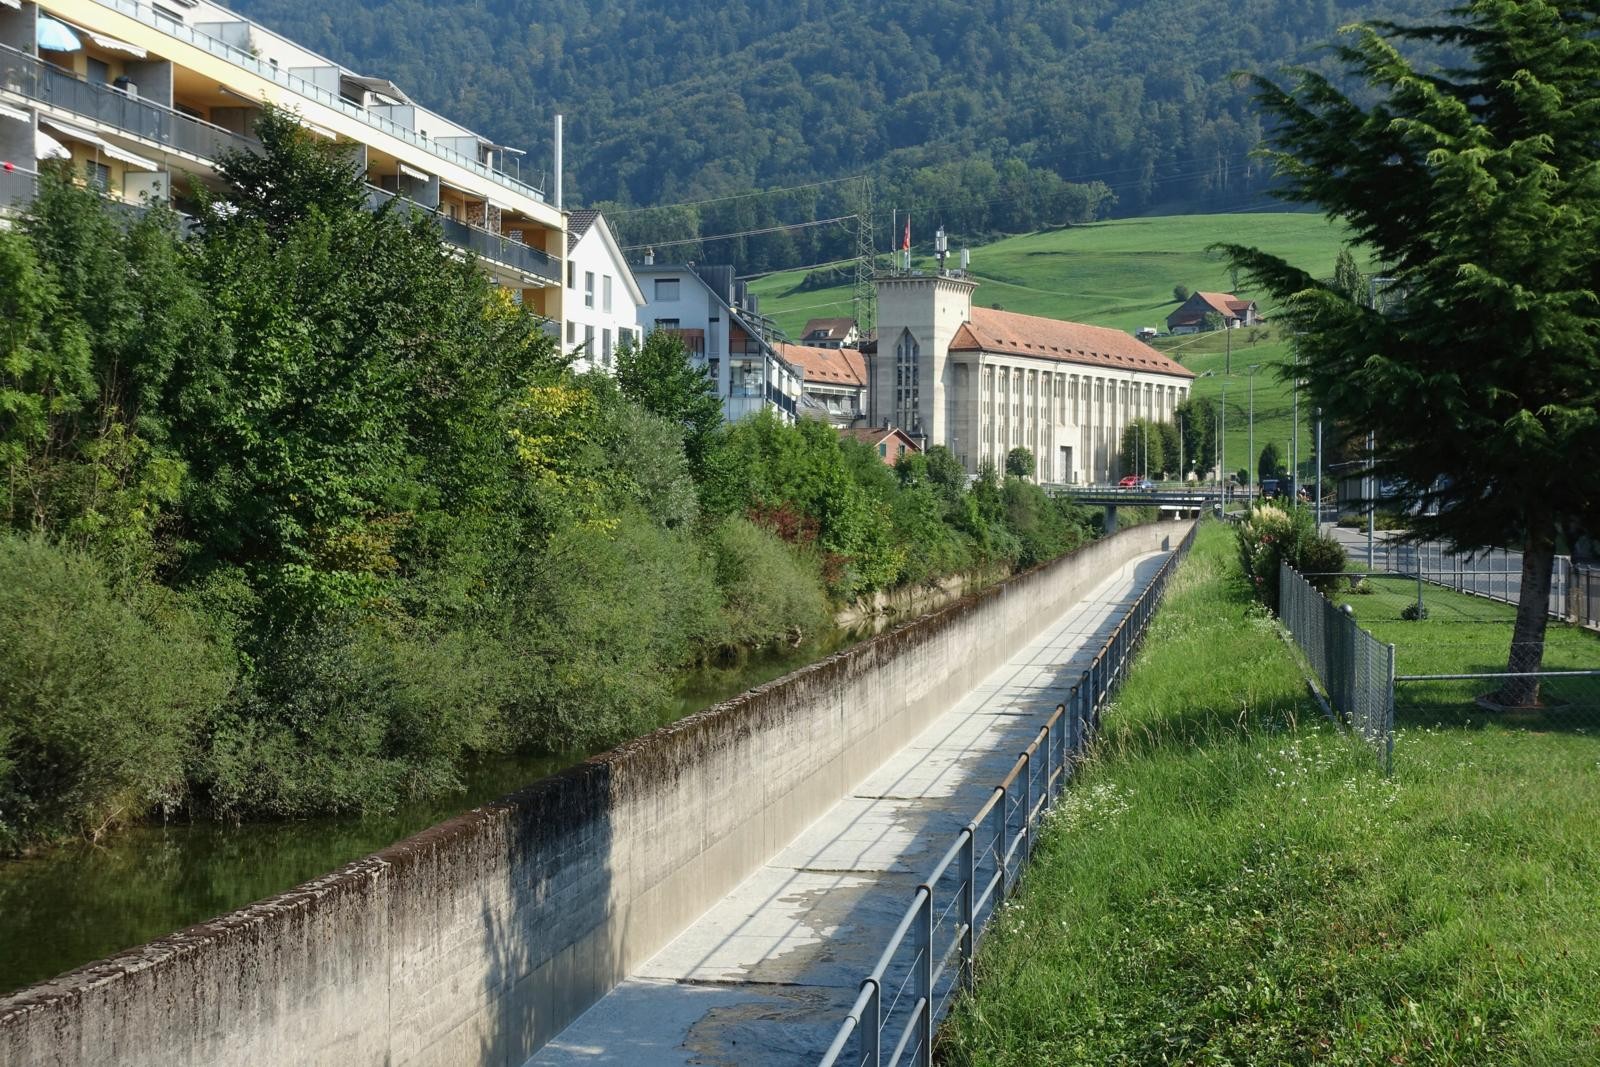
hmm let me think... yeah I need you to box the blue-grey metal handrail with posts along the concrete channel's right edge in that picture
[821,526,1195,1067]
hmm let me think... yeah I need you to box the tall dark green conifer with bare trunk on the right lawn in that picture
[1227,0,1600,705]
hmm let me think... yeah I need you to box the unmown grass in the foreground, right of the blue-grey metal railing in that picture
[941,526,1600,1064]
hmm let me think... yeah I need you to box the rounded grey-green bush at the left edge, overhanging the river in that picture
[0,534,234,853]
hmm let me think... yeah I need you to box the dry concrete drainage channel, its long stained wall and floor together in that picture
[0,523,1184,1067]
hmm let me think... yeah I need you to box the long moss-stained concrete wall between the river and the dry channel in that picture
[0,523,1187,1067]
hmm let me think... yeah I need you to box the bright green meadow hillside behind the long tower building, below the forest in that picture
[750,211,1342,483]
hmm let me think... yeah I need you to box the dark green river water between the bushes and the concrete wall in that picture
[0,630,869,993]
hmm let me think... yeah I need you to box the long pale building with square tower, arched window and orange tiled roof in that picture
[869,270,1195,483]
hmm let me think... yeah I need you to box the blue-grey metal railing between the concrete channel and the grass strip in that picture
[821,526,1195,1067]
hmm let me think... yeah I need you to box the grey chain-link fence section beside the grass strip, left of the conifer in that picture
[1278,563,1395,773]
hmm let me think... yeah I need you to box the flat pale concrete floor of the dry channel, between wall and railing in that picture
[531,553,1166,1067]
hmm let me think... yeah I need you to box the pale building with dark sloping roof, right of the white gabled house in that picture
[634,262,803,422]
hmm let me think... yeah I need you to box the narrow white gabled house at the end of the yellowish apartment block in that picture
[563,211,645,374]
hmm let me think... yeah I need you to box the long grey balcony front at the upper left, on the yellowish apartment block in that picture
[0,45,259,162]
